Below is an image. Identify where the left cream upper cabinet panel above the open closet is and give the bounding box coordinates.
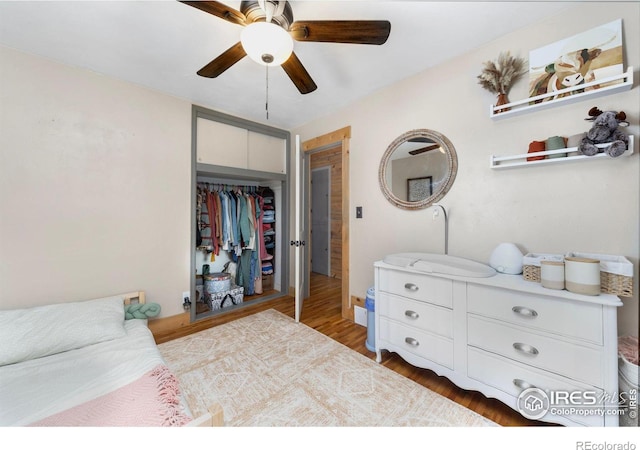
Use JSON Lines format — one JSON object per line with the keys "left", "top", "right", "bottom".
{"left": 196, "top": 119, "right": 248, "bottom": 169}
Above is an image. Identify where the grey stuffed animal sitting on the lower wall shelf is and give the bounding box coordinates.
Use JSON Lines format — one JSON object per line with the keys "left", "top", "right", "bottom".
{"left": 578, "top": 106, "right": 629, "bottom": 158}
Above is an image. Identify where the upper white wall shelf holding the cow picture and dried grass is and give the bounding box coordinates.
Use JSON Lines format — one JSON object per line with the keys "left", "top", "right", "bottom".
{"left": 489, "top": 67, "right": 633, "bottom": 120}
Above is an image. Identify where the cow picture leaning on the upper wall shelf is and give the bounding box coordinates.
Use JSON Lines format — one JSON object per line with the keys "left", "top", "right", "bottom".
{"left": 529, "top": 19, "right": 624, "bottom": 103}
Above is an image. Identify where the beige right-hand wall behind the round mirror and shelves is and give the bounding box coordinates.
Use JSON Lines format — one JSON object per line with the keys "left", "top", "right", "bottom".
{"left": 292, "top": 2, "right": 640, "bottom": 335}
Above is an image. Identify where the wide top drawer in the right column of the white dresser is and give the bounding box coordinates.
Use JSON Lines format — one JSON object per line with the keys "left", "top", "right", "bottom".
{"left": 467, "top": 285, "right": 603, "bottom": 344}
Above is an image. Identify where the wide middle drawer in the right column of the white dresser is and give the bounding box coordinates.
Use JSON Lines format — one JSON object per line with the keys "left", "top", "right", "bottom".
{"left": 467, "top": 315, "right": 604, "bottom": 386}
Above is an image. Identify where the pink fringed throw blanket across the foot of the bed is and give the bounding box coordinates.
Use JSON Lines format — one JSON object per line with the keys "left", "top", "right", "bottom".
{"left": 31, "top": 365, "right": 192, "bottom": 427}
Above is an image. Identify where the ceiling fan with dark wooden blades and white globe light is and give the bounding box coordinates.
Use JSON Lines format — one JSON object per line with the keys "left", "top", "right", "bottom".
{"left": 181, "top": 0, "right": 391, "bottom": 94}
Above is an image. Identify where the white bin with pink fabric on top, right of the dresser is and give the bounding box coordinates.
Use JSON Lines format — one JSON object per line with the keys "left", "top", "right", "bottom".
{"left": 618, "top": 336, "right": 640, "bottom": 427}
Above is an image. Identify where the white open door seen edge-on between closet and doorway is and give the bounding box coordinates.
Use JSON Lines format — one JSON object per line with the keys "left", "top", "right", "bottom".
{"left": 291, "top": 135, "right": 306, "bottom": 322}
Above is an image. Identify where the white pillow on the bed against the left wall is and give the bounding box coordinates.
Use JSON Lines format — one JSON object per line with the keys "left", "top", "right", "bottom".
{"left": 0, "top": 296, "right": 126, "bottom": 366}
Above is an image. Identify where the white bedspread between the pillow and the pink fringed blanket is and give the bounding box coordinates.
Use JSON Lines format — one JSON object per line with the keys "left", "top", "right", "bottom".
{"left": 0, "top": 319, "right": 192, "bottom": 426}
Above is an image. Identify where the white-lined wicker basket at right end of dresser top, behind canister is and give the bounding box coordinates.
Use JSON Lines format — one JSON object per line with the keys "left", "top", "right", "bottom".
{"left": 566, "top": 252, "right": 633, "bottom": 297}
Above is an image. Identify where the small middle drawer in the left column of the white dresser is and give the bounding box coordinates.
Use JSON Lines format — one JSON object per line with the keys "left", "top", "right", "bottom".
{"left": 375, "top": 292, "right": 453, "bottom": 338}
